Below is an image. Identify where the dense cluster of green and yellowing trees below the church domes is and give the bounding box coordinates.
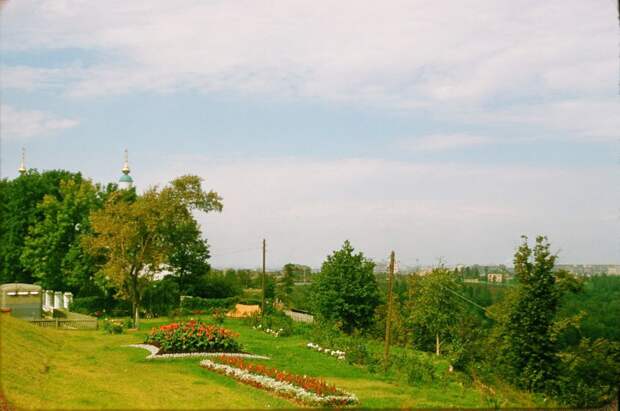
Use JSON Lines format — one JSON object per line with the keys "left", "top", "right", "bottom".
{"left": 0, "top": 170, "right": 222, "bottom": 322}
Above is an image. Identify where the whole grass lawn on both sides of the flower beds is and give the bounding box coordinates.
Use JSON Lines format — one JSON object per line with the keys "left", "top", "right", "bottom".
{"left": 0, "top": 314, "right": 542, "bottom": 409}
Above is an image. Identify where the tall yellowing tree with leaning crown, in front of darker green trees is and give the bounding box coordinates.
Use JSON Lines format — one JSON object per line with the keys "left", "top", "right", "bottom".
{"left": 84, "top": 176, "right": 222, "bottom": 327}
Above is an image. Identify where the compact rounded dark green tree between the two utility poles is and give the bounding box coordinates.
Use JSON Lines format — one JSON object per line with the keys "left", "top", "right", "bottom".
{"left": 312, "top": 241, "right": 380, "bottom": 333}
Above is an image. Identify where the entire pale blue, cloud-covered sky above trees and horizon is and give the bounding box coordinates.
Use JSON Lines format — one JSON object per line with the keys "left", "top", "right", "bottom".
{"left": 0, "top": 0, "right": 620, "bottom": 268}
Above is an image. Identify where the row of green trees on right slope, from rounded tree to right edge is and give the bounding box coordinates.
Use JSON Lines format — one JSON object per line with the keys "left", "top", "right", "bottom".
{"left": 311, "top": 237, "right": 620, "bottom": 406}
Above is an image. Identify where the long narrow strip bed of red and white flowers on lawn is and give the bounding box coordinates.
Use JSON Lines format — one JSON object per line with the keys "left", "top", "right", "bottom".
{"left": 200, "top": 356, "right": 358, "bottom": 406}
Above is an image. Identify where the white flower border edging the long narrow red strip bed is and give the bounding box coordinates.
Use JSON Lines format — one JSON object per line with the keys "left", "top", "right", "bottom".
{"left": 200, "top": 359, "right": 359, "bottom": 406}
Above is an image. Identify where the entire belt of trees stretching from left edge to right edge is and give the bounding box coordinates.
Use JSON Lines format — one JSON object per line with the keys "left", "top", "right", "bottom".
{"left": 0, "top": 170, "right": 620, "bottom": 406}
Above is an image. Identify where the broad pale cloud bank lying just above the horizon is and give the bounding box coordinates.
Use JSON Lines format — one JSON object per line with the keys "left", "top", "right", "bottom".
{"left": 134, "top": 156, "right": 620, "bottom": 267}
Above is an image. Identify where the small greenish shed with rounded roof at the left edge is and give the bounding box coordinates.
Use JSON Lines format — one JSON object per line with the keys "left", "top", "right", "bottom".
{"left": 0, "top": 283, "right": 43, "bottom": 320}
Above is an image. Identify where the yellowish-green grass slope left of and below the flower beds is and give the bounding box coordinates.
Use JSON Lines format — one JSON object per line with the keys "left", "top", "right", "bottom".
{"left": 0, "top": 314, "right": 294, "bottom": 409}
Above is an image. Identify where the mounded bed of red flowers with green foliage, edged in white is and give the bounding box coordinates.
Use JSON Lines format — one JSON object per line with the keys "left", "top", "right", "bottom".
{"left": 144, "top": 320, "right": 241, "bottom": 354}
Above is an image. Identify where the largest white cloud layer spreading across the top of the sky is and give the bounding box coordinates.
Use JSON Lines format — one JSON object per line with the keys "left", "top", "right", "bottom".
{"left": 3, "top": 0, "right": 618, "bottom": 140}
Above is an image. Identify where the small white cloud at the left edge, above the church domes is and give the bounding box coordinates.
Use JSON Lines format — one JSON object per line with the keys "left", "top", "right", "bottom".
{"left": 0, "top": 104, "right": 79, "bottom": 140}
